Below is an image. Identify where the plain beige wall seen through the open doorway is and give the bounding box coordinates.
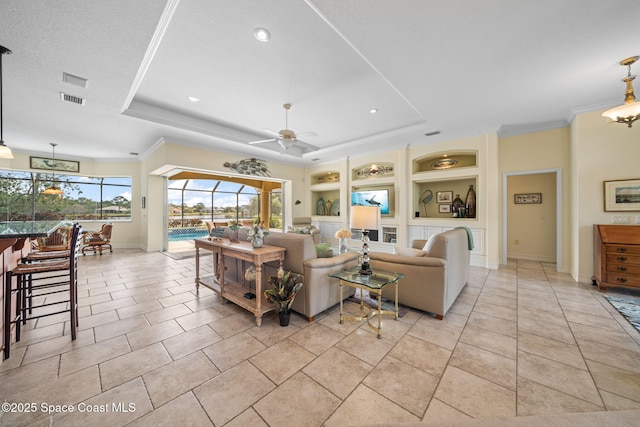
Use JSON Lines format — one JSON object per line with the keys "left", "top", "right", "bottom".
{"left": 506, "top": 173, "right": 556, "bottom": 262}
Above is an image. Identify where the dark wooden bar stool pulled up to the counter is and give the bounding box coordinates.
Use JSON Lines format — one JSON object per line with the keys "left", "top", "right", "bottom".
{"left": 4, "top": 224, "right": 82, "bottom": 359}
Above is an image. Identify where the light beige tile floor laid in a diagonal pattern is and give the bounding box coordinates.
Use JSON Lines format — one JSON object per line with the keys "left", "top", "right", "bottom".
{"left": 0, "top": 250, "right": 640, "bottom": 426}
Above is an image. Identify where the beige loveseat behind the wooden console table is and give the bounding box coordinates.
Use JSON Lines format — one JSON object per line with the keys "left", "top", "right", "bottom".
{"left": 220, "top": 229, "right": 359, "bottom": 322}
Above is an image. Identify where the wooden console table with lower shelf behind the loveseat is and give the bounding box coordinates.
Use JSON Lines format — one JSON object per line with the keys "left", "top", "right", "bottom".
{"left": 195, "top": 239, "right": 286, "bottom": 326}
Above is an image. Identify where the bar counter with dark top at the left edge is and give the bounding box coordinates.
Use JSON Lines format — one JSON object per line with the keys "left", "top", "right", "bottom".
{"left": 0, "top": 220, "right": 62, "bottom": 363}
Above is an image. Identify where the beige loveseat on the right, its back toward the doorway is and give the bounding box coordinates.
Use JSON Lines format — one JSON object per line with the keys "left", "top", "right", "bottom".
{"left": 369, "top": 228, "right": 473, "bottom": 320}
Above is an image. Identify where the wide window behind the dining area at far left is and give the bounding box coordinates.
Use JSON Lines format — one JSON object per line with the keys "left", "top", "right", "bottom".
{"left": 0, "top": 170, "right": 131, "bottom": 221}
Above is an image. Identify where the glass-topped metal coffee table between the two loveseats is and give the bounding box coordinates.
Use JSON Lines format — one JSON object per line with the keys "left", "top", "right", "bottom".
{"left": 329, "top": 266, "right": 404, "bottom": 338}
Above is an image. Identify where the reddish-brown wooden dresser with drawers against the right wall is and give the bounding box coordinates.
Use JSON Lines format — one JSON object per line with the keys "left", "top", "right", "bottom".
{"left": 591, "top": 224, "right": 640, "bottom": 292}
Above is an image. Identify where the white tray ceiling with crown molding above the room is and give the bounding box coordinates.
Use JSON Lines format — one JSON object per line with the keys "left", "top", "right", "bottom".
{"left": 0, "top": 0, "right": 640, "bottom": 164}
